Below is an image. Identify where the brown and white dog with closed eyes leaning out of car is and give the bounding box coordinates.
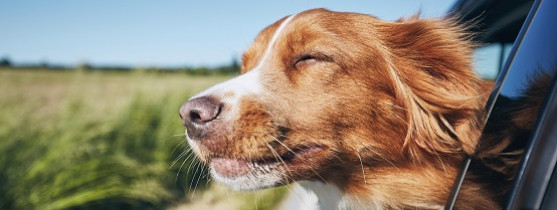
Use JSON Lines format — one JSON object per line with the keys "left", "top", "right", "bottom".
{"left": 180, "top": 9, "right": 528, "bottom": 209}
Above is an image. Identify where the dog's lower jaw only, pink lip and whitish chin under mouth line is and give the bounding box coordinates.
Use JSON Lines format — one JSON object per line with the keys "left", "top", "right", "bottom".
{"left": 210, "top": 145, "right": 326, "bottom": 184}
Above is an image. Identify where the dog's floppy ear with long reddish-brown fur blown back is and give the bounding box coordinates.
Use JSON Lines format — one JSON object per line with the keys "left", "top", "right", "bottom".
{"left": 381, "top": 18, "right": 488, "bottom": 158}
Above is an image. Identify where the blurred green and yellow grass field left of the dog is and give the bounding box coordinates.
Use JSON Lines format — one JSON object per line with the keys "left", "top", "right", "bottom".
{"left": 0, "top": 69, "right": 284, "bottom": 209}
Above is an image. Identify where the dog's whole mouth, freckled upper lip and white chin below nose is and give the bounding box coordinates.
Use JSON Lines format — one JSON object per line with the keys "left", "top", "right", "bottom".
{"left": 182, "top": 108, "right": 334, "bottom": 190}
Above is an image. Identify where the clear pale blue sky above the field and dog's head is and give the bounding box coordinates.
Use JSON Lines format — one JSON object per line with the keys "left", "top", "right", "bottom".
{"left": 0, "top": 0, "right": 454, "bottom": 67}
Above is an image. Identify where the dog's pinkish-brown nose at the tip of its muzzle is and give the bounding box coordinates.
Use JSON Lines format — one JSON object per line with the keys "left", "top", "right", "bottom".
{"left": 180, "top": 97, "right": 221, "bottom": 127}
